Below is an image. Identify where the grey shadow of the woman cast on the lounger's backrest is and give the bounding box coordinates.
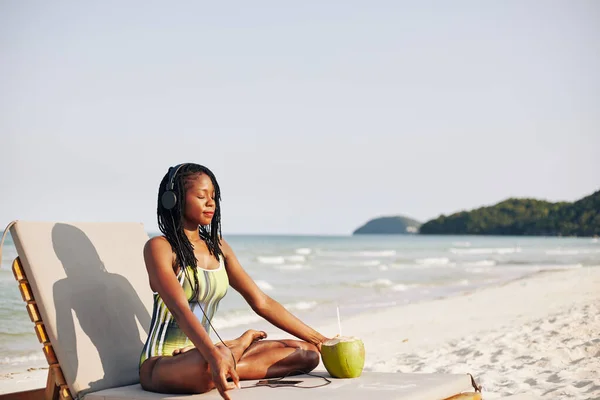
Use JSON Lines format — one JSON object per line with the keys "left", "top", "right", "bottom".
{"left": 52, "top": 224, "right": 150, "bottom": 390}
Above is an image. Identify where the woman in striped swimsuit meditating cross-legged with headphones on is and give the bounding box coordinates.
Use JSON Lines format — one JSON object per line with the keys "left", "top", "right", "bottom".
{"left": 140, "top": 164, "right": 327, "bottom": 399}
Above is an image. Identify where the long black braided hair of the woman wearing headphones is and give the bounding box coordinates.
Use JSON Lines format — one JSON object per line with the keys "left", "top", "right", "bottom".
{"left": 157, "top": 163, "right": 223, "bottom": 298}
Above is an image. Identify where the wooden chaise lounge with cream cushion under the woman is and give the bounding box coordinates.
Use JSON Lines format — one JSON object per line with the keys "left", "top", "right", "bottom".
{"left": 0, "top": 221, "right": 488, "bottom": 400}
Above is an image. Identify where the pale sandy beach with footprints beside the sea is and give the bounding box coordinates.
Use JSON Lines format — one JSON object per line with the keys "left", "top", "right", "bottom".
{"left": 0, "top": 268, "right": 600, "bottom": 399}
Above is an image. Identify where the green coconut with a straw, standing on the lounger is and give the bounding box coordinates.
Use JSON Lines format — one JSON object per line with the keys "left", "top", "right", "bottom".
{"left": 321, "top": 336, "right": 365, "bottom": 378}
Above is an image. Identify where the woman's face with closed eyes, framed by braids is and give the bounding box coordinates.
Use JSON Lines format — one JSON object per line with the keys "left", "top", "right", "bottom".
{"left": 183, "top": 173, "right": 216, "bottom": 225}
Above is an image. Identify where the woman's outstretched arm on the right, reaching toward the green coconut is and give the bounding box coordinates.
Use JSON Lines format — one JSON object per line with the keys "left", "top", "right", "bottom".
{"left": 221, "top": 240, "right": 327, "bottom": 350}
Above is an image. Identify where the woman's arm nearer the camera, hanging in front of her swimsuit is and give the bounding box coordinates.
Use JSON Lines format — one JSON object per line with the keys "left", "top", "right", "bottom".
{"left": 144, "top": 237, "right": 239, "bottom": 399}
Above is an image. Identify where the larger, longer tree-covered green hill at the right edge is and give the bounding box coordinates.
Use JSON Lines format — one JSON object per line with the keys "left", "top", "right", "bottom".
{"left": 420, "top": 191, "right": 600, "bottom": 236}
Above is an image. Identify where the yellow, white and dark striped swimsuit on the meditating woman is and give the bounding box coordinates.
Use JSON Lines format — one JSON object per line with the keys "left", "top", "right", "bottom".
{"left": 140, "top": 257, "right": 229, "bottom": 366}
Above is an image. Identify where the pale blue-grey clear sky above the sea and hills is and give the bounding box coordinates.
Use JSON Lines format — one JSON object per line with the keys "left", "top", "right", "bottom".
{"left": 0, "top": 0, "right": 600, "bottom": 235}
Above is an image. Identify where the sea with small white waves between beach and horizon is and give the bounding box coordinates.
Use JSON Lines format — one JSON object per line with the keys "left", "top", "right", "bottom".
{"left": 0, "top": 232, "right": 600, "bottom": 371}
